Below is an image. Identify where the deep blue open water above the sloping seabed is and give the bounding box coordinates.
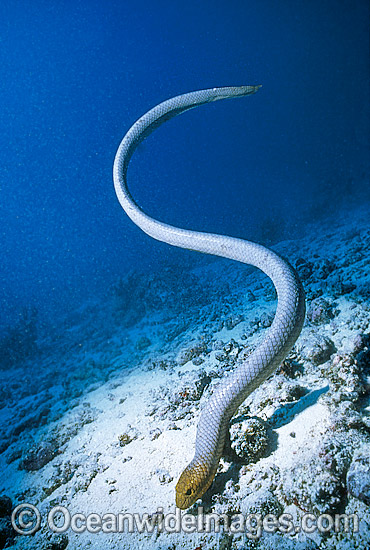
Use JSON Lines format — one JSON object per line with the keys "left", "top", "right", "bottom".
{"left": 0, "top": 0, "right": 370, "bottom": 548}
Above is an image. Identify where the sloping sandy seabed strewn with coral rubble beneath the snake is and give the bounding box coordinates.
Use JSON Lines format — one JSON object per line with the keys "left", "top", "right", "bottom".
{"left": 0, "top": 207, "right": 370, "bottom": 550}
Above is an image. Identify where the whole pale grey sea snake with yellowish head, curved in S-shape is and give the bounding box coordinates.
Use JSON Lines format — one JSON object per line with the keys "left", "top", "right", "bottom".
{"left": 113, "top": 86, "right": 305, "bottom": 510}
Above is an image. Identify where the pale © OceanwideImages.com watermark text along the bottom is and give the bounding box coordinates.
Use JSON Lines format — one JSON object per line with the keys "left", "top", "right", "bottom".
{"left": 11, "top": 503, "right": 359, "bottom": 539}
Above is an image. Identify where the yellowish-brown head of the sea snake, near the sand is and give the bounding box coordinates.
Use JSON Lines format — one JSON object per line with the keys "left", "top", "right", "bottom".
{"left": 176, "top": 460, "right": 217, "bottom": 510}
